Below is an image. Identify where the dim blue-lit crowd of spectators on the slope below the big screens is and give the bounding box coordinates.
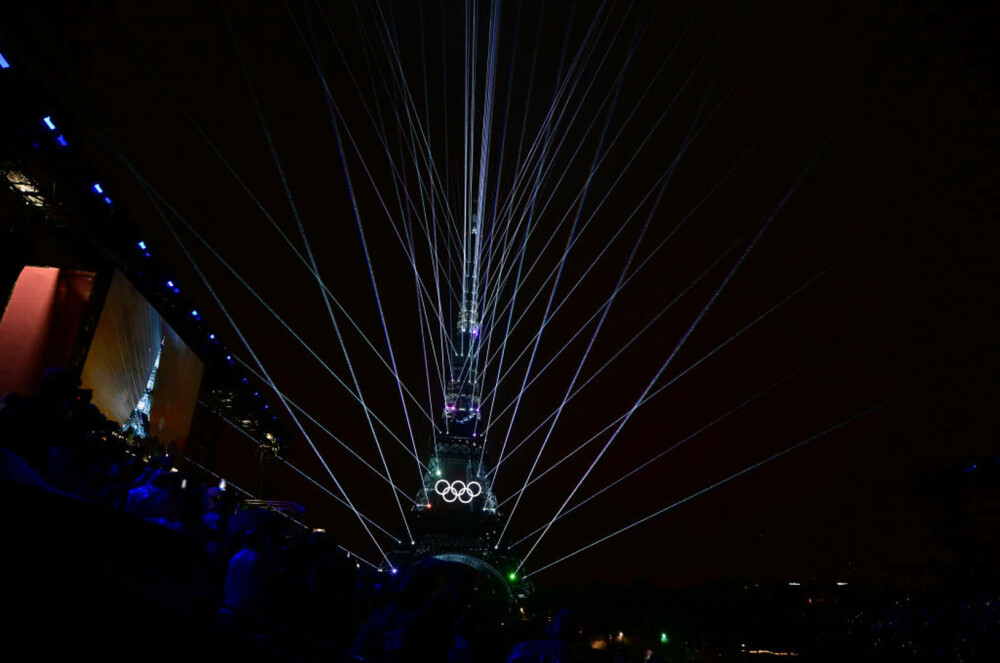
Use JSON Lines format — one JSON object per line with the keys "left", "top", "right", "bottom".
{"left": 0, "top": 369, "right": 613, "bottom": 663}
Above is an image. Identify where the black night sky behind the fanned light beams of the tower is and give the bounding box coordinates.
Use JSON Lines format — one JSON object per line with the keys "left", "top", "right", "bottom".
{"left": 2, "top": 0, "right": 997, "bottom": 585}
